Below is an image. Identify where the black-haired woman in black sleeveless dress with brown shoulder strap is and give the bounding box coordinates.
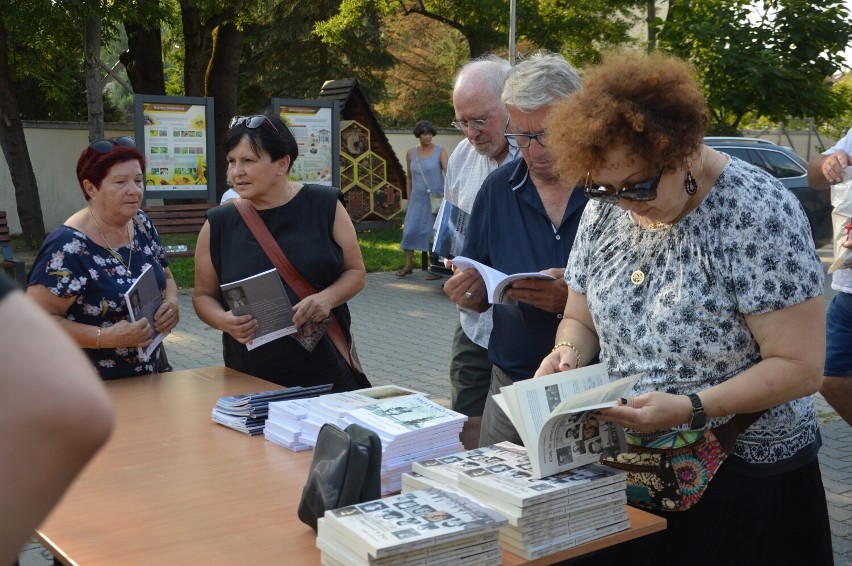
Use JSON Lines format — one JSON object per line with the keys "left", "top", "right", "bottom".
{"left": 192, "top": 116, "right": 366, "bottom": 391}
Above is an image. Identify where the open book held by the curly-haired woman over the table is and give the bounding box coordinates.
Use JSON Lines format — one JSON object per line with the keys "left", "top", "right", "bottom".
{"left": 494, "top": 364, "right": 639, "bottom": 479}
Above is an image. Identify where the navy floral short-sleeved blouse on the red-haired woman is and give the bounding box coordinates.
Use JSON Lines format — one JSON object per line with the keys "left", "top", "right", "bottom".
{"left": 28, "top": 210, "right": 169, "bottom": 379}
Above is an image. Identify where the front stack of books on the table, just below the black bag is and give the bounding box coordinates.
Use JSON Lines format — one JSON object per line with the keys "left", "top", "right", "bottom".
{"left": 317, "top": 489, "right": 506, "bottom": 566}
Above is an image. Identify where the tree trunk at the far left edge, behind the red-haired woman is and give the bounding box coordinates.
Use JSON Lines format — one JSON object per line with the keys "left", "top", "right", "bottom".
{"left": 0, "top": 18, "right": 45, "bottom": 249}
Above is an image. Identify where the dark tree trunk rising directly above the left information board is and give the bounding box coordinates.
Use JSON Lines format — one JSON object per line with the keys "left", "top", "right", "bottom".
{"left": 121, "top": 18, "right": 166, "bottom": 96}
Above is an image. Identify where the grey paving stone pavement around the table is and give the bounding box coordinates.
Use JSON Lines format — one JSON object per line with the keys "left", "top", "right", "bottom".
{"left": 20, "top": 264, "right": 852, "bottom": 566}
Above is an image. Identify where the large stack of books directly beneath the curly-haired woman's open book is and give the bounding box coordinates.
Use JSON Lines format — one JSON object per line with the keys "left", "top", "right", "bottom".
{"left": 403, "top": 442, "right": 630, "bottom": 560}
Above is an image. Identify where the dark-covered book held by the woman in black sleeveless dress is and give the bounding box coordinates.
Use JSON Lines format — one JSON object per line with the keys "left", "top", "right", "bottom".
{"left": 220, "top": 269, "right": 296, "bottom": 350}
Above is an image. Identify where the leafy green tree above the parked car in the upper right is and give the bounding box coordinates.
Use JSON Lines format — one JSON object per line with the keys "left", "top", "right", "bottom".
{"left": 658, "top": 0, "right": 852, "bottom": 134}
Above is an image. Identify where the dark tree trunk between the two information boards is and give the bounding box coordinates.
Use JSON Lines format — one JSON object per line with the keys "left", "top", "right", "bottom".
{"left": 205, "top": 23, "right": 243, "bottom": 202}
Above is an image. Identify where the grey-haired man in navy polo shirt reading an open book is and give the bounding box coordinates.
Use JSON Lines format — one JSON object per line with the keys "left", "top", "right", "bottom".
{"left": 444, "top": 53, "right": 587, "bottom": 446}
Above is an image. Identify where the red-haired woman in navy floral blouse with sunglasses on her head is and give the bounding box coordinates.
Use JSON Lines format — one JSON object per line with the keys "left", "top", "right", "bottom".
{"left": 27, "top": 136, "right": 179, "bottom": 379}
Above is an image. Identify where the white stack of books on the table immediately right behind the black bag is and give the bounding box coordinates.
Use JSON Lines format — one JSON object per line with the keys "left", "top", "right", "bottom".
{"left": 341, "top": 395, "right": 467, "bottom": 495}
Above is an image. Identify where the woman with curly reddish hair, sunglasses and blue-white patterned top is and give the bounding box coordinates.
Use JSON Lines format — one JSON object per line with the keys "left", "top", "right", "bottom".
{"left": 537, "top": 53, "right": 833, "bottom": 565}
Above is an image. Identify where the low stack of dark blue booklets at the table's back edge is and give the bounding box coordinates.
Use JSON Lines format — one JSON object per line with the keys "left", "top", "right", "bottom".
{"left": 211, "top": 384, "right": 331, "bottom": 436}
